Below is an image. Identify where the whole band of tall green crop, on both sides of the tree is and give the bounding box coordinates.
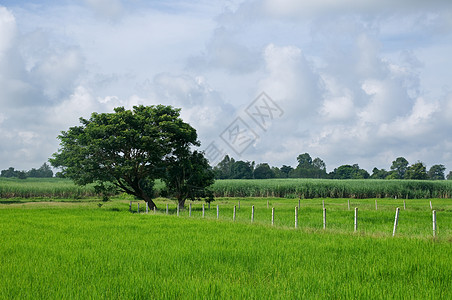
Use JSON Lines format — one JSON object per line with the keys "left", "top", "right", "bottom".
{"left": 0, "top": 178, "right": 452, "bottom": 199}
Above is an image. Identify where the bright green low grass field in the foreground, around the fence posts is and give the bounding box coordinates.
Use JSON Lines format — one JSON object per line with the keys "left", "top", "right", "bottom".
{"left": 0, "top": 198, "right": 452, "bottom": 299}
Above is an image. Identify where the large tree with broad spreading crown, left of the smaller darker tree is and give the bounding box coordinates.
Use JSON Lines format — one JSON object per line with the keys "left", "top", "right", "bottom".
{"left": 49, "top": 105, "right": 204, "bottom": 209}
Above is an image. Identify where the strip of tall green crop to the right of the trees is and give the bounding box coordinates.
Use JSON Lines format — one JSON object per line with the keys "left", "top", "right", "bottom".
{"left": 212, "top": 179, "right": 452, "bottom": 199}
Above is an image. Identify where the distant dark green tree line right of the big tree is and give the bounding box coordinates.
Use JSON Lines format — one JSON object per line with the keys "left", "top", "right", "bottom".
{"left": 213, "top": 153, "right": 452, "bottom": 180}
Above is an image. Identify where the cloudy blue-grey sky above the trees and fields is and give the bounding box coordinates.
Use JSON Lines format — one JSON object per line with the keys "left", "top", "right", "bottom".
{"left": 0, "top": 0, "right": 452, "bottom": 172}
